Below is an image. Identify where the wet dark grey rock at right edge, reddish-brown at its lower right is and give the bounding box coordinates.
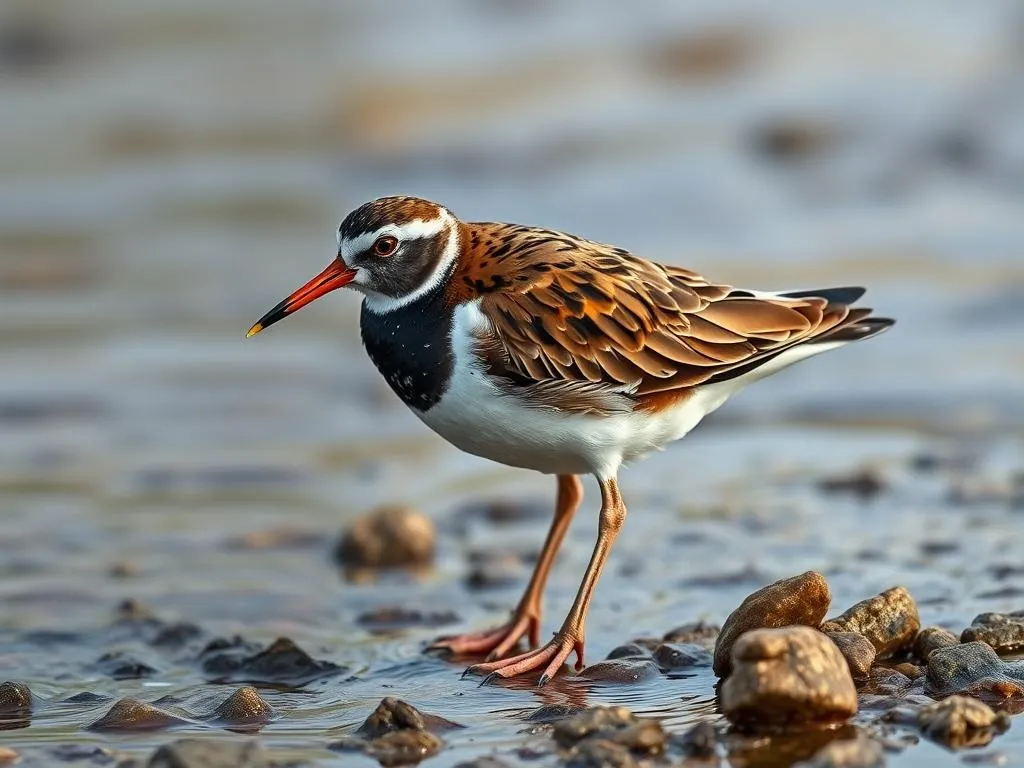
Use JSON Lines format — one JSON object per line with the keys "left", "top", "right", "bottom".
{"left": 925, "top": 642, "right": 1024, "bottom": 699}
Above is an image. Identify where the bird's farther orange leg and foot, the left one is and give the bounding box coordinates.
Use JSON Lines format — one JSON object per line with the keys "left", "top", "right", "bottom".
{"left": 429, "top": 475, "right": 583, "bottom": 660}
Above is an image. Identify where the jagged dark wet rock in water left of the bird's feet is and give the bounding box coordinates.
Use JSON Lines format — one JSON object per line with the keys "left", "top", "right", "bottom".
{"left": 203, "top": 637, "right": 345, "bottom": 686}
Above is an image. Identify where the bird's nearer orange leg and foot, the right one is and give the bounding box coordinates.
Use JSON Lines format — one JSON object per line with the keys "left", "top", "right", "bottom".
{"left": 467, "top": 478, "right": 626, "bottom": 685}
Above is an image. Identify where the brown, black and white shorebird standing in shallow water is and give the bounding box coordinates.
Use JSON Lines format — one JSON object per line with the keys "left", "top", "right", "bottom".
{"left": 248, "top": 196, "right": 894, "bottom": 685}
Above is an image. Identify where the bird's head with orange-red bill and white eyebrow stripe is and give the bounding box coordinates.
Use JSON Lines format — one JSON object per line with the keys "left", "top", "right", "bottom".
{"left": 248, "top": 197, "right": 459, "bottom": 336}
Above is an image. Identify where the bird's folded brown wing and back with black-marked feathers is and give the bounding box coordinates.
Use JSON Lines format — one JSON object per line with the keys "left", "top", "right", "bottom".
{"left": 453, "top": 224, "right": 869, "bottom": 411}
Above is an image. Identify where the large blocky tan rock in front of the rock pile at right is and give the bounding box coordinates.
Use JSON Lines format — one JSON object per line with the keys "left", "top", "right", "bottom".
{"left": 720, "top": 627, "right": 857, "bottom": 727}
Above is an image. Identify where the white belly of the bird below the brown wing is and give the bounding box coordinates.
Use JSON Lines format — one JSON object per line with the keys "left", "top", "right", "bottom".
{"left": 414, "top": 305, "right": 728, "bottom": 477}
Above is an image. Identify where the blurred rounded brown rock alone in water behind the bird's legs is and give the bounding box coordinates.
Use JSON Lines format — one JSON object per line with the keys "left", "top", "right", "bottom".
{"left": 335, "top": 505, "right": 434, "bottom": 568}
